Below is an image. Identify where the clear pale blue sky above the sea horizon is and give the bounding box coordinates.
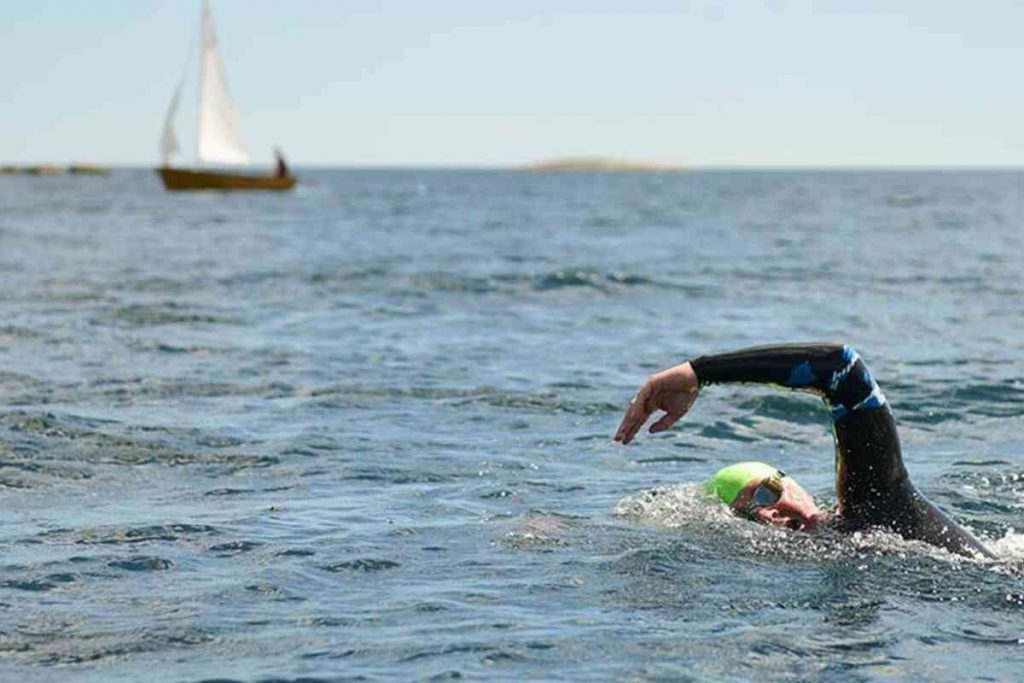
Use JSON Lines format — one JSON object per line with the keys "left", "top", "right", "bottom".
{"left": 0, "top": 0, "right": 1024, "bottom": 168}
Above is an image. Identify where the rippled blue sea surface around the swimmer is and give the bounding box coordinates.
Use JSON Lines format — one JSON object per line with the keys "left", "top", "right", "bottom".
{"left": 0, "top": 169, "right": 1024, "bottom": 682}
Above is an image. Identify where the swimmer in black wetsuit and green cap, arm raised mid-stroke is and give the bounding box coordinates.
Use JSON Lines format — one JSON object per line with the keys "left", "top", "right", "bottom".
{"left": 614, "top": 343, "right": 993, "bottom": 557}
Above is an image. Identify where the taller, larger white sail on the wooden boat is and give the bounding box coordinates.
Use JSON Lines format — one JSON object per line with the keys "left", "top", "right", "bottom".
{"left": 198, "top": 0, "right": 251, "bottom": 164}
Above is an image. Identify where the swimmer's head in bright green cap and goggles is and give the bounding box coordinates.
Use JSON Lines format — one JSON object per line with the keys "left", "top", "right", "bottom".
{"left": 705, "top": 462, "right": 822, "bottom": 531}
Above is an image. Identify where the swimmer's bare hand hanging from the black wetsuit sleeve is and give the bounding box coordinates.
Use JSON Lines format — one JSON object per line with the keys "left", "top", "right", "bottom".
{"left": 614, "top": 362, "right": 700, "bottom": 444}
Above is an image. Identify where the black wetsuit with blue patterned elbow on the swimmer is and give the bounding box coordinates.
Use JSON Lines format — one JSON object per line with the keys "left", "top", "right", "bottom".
{"left": 690, "top": 343, "right": 992, "bottom": 557}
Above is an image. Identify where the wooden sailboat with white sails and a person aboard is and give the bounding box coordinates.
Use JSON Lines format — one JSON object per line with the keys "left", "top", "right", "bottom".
{"left": 157, "top": 0, "right": 296, "bottom": 190}
